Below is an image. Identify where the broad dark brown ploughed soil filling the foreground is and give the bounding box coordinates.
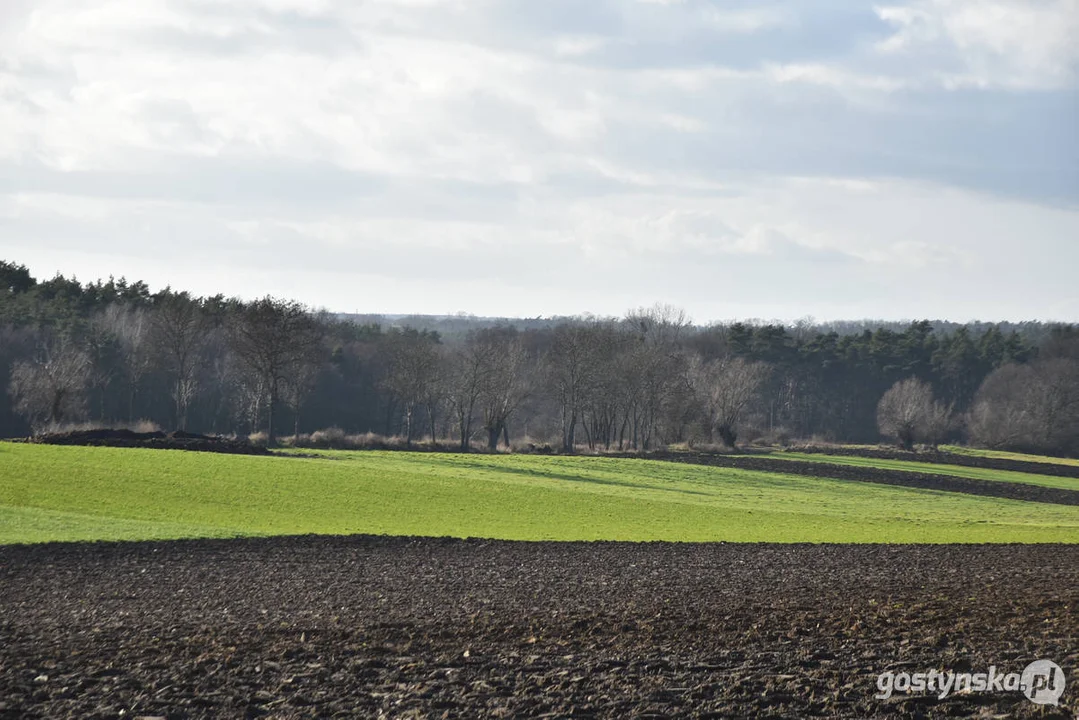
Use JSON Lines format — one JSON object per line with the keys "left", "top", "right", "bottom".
{"left": 0, "top": 536, "right": 1079, "bottom": 720}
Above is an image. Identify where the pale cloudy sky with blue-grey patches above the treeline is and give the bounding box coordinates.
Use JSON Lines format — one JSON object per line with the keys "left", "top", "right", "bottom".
{"left": 0, "top": 0, "right": 1079, "bottom": 322}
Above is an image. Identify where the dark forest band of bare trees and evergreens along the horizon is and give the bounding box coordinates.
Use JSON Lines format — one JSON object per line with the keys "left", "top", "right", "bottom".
{"left": 6, "top": 261, "right": 1079, "bottom": 454}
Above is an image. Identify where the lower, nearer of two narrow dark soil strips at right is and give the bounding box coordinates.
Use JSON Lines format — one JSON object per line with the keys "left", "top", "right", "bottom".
{"left": 622, "top": 450, "right": 1079, "bottom": 505}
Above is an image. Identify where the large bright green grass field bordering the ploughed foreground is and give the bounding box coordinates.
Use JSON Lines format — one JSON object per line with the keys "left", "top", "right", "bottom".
{"left": 0, "top": 443, "right": 1079, "bottom": 544}
